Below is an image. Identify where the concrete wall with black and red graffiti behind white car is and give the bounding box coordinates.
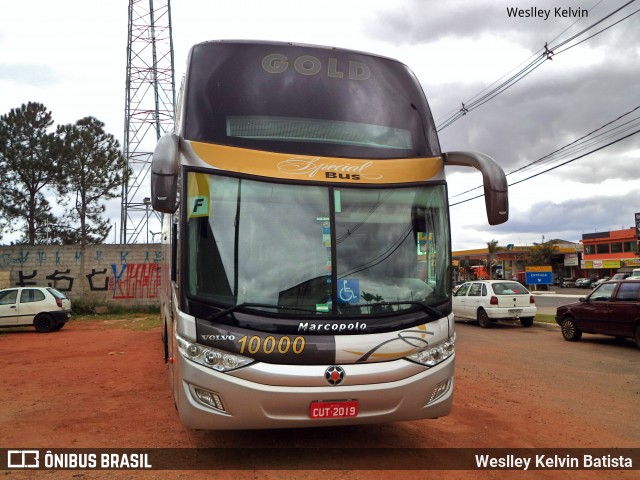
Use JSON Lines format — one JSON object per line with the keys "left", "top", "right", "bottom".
{"left": 0, "top": 244, "right": 162, "bottom": 307}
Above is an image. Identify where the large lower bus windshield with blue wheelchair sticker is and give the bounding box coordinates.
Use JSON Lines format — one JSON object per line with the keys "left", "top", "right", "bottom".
{"left": 186, "top": 172, "right": 450, "bottom": 316}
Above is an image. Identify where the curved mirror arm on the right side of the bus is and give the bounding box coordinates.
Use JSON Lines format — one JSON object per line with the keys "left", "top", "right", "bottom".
{"left": 442, "top": 152, "right": 509, "bottom": 225}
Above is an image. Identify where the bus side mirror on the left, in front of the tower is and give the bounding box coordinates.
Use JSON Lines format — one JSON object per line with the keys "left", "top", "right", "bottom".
{"left": 151, "top": 133, "right": 180, "bottom": 213}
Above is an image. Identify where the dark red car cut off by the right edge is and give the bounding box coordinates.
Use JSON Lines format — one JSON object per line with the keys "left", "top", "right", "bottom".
{"left": 556, "top": 279, "right": 640, "bottom": 348}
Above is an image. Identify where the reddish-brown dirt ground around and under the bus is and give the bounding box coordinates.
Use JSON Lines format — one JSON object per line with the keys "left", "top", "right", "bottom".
{"left": 0, "top": 320, "right": 640, "bottom": 480}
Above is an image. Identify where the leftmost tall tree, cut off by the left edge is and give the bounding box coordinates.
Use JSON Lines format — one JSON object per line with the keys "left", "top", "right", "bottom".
{"left": 0, "top": 102, "right": 61, "bottom": 245}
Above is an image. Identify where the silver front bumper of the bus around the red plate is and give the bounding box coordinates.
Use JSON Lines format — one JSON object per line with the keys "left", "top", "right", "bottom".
{"left": 173, "top": 355, "right": 455, "bottom": 430}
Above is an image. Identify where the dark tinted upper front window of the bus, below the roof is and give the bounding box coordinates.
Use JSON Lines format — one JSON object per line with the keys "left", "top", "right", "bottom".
{"left": 182, "top": 42, "right": 440, "bottom": 158}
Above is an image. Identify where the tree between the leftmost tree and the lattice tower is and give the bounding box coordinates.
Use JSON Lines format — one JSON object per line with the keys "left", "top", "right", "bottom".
{"left": 58, "top": 117, "right": 127, "bottom": 245}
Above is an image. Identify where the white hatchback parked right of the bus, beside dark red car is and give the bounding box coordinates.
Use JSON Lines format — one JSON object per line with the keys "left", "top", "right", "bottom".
{"left": 453, "top": 280, "right": 537, "bottom": 328}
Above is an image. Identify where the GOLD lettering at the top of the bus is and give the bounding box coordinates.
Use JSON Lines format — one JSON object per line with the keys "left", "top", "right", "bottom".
{"left": 262, "top": 53, "right": 371, "bottom": 80}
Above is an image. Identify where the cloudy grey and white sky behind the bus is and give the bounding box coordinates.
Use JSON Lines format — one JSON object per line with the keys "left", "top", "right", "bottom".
{"left": 0, "top": 0, "right": 640, "bottom": 250}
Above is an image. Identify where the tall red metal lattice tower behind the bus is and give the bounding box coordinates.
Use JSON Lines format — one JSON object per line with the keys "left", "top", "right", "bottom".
{"left": 120, "top": 0, "right": 175, "bottom": 243}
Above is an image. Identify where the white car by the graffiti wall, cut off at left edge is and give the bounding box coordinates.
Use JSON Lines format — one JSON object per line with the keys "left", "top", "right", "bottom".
{"left": 0, "top": 287, "right": 71, "bottom": 332}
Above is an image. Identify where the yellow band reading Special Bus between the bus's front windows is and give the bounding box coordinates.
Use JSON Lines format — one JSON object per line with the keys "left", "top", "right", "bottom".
{"left": 189, "top": 142, "right": 443, "bottom": 184}
